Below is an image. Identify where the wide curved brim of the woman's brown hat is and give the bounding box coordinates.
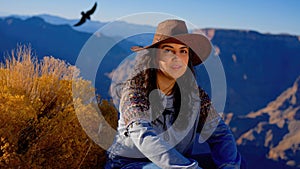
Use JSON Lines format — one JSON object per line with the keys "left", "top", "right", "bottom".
{"left": 131, "top": 34, "right": 212, "bottom": 66}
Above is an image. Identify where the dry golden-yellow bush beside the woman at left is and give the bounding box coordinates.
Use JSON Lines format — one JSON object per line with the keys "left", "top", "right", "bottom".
{"left": 0, "top": 46, "right": 117, "bottom": 168}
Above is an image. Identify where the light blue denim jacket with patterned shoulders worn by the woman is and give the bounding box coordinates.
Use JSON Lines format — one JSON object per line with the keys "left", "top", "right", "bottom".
{"left": 108, "top": 88, "right": 241, "bottom": 169}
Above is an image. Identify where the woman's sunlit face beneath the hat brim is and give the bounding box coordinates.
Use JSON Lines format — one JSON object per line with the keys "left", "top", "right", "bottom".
{"left": 156, "top": 43, "right": 189, "bottom": 79}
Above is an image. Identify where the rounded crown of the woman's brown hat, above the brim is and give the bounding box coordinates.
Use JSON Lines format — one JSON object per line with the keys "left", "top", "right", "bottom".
{"left": 153, "top": 19, "right": 188, "bottom": 43}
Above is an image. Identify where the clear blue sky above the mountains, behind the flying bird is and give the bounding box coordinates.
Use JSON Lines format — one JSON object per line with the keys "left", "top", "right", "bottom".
{"left": 0, "top": 0, "right": 300, "bottom": 35}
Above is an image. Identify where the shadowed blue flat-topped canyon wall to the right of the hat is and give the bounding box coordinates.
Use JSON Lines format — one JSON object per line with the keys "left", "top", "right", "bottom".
{"left": 195, "top": 29, "right": 300, "bottom": 114}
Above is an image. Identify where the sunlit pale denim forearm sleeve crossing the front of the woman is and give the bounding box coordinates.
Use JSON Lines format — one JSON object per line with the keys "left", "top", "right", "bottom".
{"left": 128, "top": 120, "right": 201, "bottom": 169}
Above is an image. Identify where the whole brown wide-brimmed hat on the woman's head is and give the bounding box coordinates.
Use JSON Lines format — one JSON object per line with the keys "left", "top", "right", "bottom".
{"left": 131, "top": 19, "right": 212, "bottom": 66}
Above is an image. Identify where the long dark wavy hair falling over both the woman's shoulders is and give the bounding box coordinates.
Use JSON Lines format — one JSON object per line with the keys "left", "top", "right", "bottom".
{"left": 125, "top": 48, "right": 202, "bottom": 130}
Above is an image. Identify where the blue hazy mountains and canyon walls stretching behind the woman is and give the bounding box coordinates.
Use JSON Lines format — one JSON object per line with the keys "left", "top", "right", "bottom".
{"left": 0, "top": 15, "right": 300, "bottom": 168}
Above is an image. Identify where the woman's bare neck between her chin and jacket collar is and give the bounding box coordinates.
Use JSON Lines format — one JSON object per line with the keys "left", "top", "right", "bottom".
{"left": 156, "top": 71, "right": 176, "bottom": 95}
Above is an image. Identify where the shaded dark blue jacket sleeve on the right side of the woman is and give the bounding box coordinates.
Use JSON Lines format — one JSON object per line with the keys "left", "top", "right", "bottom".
{"left": 198, "top": 90, "right": 241, "bottom": 169}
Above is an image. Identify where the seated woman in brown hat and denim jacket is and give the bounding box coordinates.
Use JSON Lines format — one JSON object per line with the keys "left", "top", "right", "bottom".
{"left": 105, "top": 20, "right": 241, "bottom": 169}
